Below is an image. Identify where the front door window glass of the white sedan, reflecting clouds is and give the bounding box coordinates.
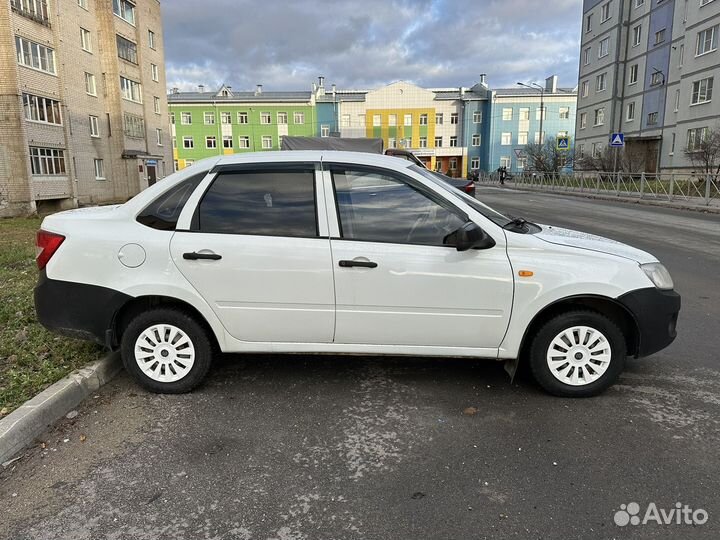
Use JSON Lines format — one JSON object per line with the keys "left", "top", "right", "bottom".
{"left": 331, "top": 166, "right": 466, "bottom": 246}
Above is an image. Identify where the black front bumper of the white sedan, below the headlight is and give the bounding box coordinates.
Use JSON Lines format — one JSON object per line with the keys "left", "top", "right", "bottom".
{"left": 618, "top": 287, "right": 680, "bottom": 358}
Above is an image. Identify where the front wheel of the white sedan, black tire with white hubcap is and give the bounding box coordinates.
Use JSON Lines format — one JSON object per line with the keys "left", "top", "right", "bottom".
{"left": 529, "top": 311, "right": 627, "bottom": 397}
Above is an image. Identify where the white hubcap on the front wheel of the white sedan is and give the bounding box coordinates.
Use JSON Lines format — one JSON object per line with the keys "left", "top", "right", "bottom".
{"left": 547, "top": 326, "right": 612, "bottom": 386}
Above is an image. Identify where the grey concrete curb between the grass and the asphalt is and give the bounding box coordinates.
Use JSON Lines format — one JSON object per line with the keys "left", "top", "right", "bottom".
{"left": 0, "top": 353, "right": 122, "bottom": 463}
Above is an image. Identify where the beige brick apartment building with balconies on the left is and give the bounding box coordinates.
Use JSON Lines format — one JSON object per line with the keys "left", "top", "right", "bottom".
{"left": 0, "top": 0, "right": 172, "bottom": 216}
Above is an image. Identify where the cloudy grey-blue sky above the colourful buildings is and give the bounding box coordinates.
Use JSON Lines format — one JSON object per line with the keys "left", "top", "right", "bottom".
{"left": 162, "top": 0, "right": 582, "bottom": 90}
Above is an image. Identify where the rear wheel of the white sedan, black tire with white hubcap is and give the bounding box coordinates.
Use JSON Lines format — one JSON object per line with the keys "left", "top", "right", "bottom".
{"left": 120, "top": 308, "right": 213, "bottom": 394}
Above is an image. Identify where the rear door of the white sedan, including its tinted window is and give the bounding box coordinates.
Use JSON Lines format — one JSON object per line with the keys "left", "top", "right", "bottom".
{"left": 170, "top": 163, "right": 335, "bottom": 343}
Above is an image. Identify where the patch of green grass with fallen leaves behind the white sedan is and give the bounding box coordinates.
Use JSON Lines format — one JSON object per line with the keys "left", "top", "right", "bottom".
{"left": 0, "top": 218, "right": 103, "bottom": 417}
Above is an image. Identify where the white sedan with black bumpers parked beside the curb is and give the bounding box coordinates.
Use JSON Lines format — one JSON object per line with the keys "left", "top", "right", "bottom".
{"left": 35, "top": 151, "right": 680, "bottom": 396}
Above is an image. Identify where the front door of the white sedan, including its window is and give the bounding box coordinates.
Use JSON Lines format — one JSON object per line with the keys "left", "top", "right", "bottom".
{"left": 324, "top": 164, "right": 513, "bottom": 354}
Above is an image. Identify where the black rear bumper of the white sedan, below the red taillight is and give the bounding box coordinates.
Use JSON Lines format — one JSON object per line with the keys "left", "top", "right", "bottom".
{"left": 35, "top": 270, "right": 131, "bottom": 347}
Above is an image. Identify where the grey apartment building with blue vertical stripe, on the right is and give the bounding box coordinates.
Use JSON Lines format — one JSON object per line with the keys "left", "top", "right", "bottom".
{"left": 576, "top": 0, "right": 720, "bottom": 172}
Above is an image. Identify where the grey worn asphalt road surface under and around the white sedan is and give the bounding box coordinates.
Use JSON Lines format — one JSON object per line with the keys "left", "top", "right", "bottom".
{"left": 0, "top": 188, "right": 720, "bottom": 540}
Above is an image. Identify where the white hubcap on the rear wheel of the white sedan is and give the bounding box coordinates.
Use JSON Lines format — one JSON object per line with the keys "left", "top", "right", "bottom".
{"left": 135, "top": 324, "right": 195, "bottom": 382}
